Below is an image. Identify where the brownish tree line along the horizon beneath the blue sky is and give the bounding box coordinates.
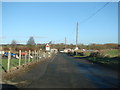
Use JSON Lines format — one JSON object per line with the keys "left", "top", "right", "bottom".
{"left": 2, "top": 37, "right": 120, "bottom": 51}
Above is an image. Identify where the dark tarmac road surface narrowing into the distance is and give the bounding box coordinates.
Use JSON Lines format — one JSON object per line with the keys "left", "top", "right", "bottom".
{"left": 3, "top": 53, "right": 119, "bottom": 88}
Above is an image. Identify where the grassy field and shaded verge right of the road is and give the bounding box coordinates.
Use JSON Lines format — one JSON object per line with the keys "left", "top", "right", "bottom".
{"left": 70, "top": 49, "right": 120, "bottom": 69}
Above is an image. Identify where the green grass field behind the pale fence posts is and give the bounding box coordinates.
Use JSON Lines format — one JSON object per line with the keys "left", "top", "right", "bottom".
{"left": 0, "top": 52, "right": 52, "bottom": 72}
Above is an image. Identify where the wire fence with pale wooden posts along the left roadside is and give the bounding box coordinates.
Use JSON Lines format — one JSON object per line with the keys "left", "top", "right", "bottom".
{"left": 0, "top": 50, "right": 53, "bottom": 72}
